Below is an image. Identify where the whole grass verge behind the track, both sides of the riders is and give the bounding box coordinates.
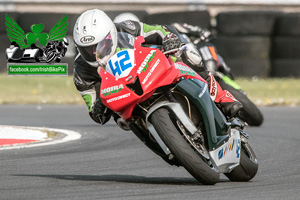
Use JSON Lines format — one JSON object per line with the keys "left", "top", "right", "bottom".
{"left": 0, "top": 75, "right": 300, "bottom": 106}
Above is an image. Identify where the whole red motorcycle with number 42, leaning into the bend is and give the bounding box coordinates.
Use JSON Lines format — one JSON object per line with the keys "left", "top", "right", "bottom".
{"left": 98, "top": 33, "right": 258, "bottom": 184}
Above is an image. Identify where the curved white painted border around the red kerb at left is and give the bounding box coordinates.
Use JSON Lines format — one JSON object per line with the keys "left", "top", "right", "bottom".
{"left": 0, "top": 126, "right": 81, "bottom": 150}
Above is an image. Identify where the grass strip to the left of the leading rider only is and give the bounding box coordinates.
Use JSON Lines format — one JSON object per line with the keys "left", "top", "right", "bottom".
{"left": 0, "top": 75, "right": 84, "bottom": 104}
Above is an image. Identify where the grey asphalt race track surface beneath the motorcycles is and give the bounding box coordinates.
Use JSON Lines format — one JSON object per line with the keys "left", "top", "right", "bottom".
{"left": 0, "top": 105, "right": 300, "bottom": 200}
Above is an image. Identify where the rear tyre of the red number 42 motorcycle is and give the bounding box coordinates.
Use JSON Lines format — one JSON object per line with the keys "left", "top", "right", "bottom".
{"left": 225, "top": 142, "right": 258, "bottom": 182}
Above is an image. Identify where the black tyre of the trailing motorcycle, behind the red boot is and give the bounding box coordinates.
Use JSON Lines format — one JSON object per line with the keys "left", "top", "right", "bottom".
{"left": 218, "top": 79, "right": 264, "bottom": 126}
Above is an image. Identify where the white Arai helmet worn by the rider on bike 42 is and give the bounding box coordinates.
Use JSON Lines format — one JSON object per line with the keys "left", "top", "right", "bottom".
{"left": 73, "top": 9, "right": 117, "bottom": 67}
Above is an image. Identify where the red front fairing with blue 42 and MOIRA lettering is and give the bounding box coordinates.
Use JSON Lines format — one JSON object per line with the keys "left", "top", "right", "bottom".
{"left": 98, "top": 37, "right": 204, "bottom": 119}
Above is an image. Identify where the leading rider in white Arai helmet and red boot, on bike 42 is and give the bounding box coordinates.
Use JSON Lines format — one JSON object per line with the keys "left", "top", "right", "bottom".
{"left": 73, "top": 9, "right": 242, "bottom": 124}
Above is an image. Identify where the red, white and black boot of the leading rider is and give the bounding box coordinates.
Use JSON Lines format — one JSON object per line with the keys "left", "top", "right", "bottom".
{"left": 208, "top": 74, "right": 243, "bottom": 118}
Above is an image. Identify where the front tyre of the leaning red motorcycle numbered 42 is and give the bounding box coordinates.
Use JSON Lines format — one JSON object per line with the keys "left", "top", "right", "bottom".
{"left": 151, "top": 108, "right": 220, "bottom": 185}
